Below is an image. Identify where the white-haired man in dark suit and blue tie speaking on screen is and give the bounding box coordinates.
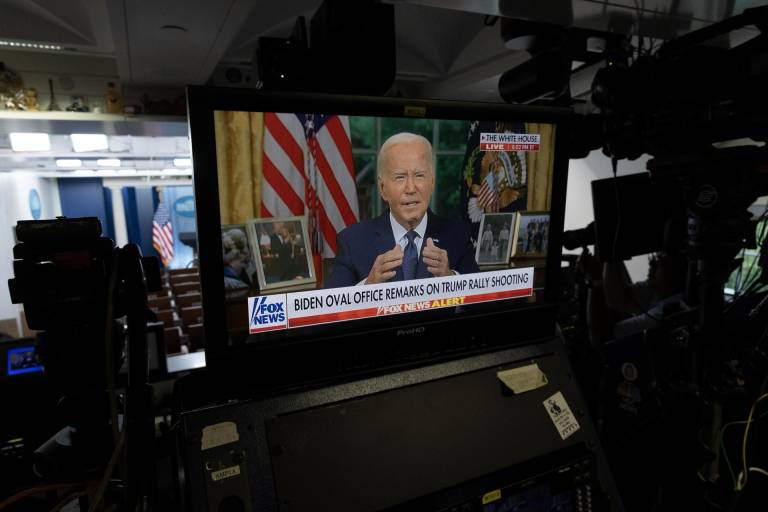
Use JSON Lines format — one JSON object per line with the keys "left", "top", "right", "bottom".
{"left": 325, "top": 133, "right": 479, "bottom": 288}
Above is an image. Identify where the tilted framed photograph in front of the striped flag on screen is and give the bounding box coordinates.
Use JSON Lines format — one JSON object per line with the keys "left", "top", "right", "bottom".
{"left": 248, "top": 217, "right": 317, "bottom": 291}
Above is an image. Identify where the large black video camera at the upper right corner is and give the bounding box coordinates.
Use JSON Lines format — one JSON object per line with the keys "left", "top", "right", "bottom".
{"left": 592, "top": 7, "right": 768, "bottom": 159}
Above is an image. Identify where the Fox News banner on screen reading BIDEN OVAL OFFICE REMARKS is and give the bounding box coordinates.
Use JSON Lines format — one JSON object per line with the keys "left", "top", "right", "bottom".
{"left": 248, "top": 268, "right": 533, "bottom": 334}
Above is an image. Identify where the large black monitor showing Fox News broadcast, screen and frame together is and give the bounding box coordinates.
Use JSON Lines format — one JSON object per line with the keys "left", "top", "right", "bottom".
{"left": 187, "top": 87, "right": 570, "bottom": 383}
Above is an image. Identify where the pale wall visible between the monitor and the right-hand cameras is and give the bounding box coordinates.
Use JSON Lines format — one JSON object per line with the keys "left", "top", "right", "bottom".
{"left": 565, "top": 150, "right": 649, "bottom": 281}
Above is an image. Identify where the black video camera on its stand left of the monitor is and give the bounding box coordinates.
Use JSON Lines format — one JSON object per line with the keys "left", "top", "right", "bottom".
{"left": 8, "top": 217, "right": 160, "bottom": 506}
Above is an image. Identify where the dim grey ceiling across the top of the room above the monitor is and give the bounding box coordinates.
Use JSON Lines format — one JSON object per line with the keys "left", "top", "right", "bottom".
{"left": 0, "top": 0, "right": 764, "bottom": 97}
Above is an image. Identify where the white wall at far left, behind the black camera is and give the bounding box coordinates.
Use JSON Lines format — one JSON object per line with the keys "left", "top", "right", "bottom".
{"left": 0, "top": 173, "right": 61, "bottom": 320}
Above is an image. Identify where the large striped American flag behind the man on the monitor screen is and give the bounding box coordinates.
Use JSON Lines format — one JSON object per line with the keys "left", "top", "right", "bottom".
{"left": 261, "top": 113, "right": 360, "bottom": 257}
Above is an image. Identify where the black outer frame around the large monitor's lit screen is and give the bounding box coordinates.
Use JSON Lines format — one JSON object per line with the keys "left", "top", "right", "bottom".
{"left": 187, "top": 86, "right": 572, "bottom": 387}
